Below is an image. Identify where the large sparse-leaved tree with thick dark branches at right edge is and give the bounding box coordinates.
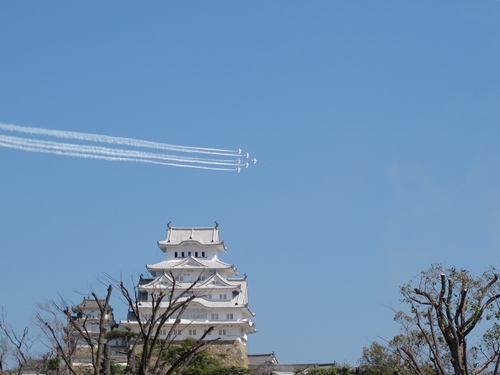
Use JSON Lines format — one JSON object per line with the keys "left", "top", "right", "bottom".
{"left": 391, "top": 265, "right": 500, "bottom": 375}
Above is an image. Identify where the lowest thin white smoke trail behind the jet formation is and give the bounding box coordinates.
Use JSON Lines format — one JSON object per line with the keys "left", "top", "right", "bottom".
{"left": 0, "top": 138, "right": 237, "bottom": 172}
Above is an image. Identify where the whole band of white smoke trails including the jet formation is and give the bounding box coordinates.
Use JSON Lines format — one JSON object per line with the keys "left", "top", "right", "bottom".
{"left": 0, "top": 123, "right": 252, "bottom": 172}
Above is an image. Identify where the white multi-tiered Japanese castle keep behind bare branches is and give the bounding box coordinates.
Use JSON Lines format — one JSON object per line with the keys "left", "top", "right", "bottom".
{"left": 120, "top": 222, "right": 256, "bottom": 344}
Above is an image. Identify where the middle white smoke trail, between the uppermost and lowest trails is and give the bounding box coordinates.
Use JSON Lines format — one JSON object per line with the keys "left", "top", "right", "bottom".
{"left": 0, "top": 134, "right": 241, "bottom": 166}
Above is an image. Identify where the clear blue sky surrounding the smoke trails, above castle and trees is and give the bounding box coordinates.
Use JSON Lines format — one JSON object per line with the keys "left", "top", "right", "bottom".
{"left": 0, "top": 0, "right": 500, "bottom": 365}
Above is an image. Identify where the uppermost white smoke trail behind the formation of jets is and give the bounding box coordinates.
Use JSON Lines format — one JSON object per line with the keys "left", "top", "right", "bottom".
{"left": 0, "top": 123, "right": 241, "bottom": 156}
